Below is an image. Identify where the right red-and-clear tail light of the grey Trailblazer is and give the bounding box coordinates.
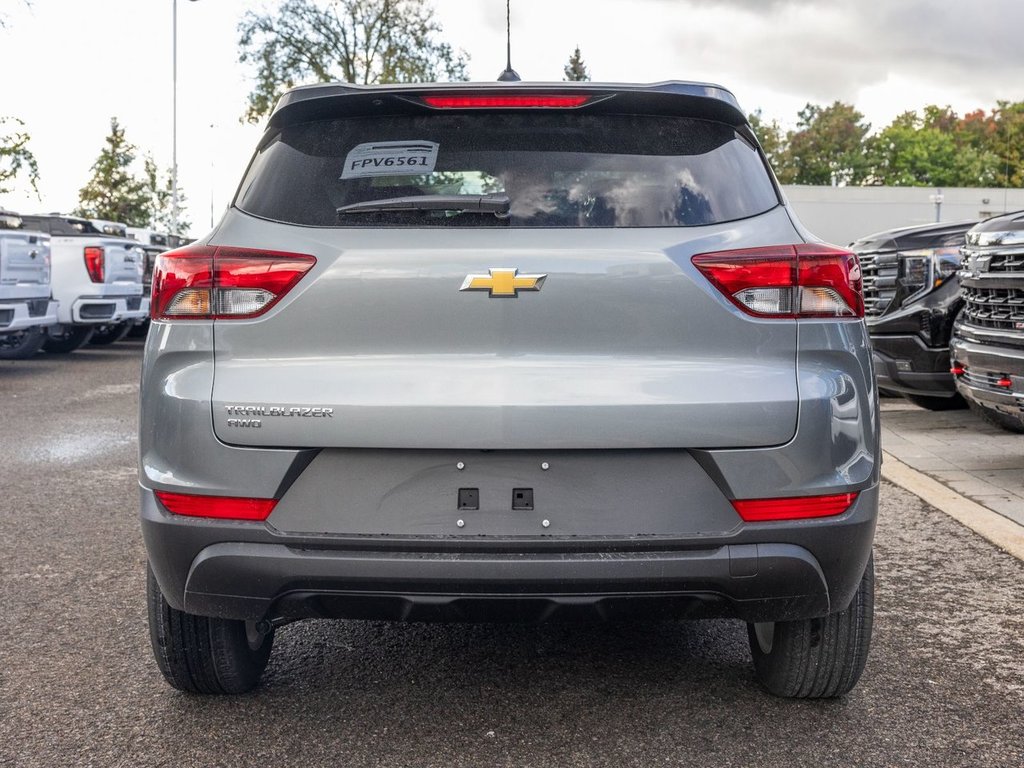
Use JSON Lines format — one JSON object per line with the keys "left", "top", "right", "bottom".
{"left": 692, "top": 243, "right": 864, "bottom": 317}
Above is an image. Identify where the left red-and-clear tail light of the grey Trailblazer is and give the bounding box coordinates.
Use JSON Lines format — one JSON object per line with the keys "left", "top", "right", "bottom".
{"left": 151, "top": 246, "right": 316, "bottom": 319}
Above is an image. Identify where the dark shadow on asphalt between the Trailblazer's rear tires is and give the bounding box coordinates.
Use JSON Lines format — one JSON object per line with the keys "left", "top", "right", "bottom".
{"left": 263, "top": 621, "right": 754, "bottom": 697}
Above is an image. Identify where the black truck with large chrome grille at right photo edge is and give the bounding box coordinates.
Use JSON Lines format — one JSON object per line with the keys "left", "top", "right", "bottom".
{"left": 951, "top": 211, "right": 1024, "bottom": 432}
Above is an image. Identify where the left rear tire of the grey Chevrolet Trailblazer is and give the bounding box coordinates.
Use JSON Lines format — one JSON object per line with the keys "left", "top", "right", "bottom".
{"left": 146, "top": 568, "right": 273, "bottom": 694}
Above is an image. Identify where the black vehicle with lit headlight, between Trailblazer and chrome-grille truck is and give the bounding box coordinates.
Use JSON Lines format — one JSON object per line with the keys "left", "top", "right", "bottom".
{"left": 852, "top": 221, "right": 974, "bottom": 411}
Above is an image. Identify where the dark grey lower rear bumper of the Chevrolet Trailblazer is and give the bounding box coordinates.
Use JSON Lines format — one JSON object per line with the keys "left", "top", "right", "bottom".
{"left": 141, "top": 485, "right": 878, "bottom": 621}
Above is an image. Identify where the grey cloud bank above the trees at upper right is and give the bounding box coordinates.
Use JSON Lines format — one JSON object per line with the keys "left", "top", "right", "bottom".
{"left": 657, "top": 0, "right": 1024, "bottom": 106}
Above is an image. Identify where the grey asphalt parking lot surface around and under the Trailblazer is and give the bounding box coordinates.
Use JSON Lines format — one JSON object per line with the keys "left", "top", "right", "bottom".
{"left": 0, "top": 343, "right": 1024, "bottom": 768}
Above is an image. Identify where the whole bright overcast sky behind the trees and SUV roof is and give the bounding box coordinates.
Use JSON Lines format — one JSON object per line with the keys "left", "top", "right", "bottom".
{"left": 0, "top": 0, "right": 1024, "bottom": 236}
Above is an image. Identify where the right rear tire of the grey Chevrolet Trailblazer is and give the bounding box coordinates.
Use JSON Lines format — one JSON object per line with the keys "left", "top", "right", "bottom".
{"left": 746, "top": 557, "right": 874, "bottom": 698}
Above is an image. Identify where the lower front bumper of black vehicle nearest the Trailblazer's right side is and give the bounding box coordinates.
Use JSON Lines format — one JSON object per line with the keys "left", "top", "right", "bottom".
{"left": 871, "top": 336, "right": 956, "bottom": 397}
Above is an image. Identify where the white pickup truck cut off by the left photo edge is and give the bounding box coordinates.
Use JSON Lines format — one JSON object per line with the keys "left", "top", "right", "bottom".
{"left": 0, "top": 211, "right": 57, "bottom": 360}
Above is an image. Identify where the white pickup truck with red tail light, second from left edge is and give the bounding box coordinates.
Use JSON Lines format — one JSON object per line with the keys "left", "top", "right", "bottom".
{"left": 23, "top": 214, "right": 150, "bottom": 352}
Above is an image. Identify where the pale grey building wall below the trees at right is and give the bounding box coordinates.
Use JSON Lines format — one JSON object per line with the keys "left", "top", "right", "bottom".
{"left": 782, "top": 184, "right": 1024, "bottom": 246}
